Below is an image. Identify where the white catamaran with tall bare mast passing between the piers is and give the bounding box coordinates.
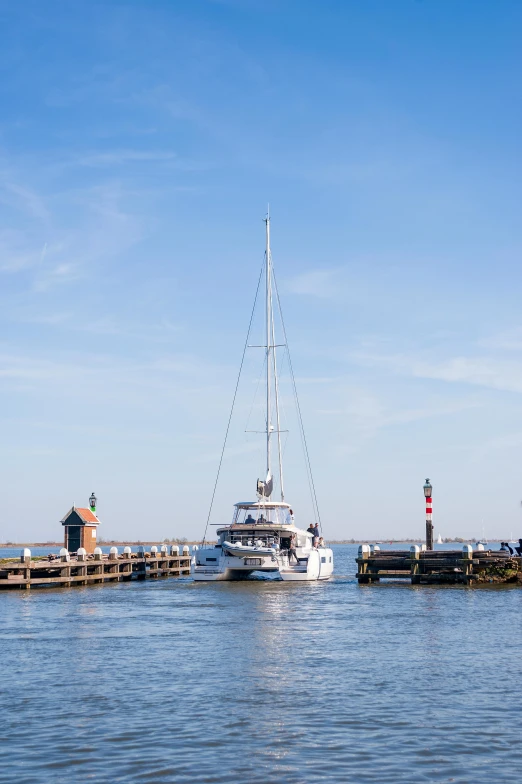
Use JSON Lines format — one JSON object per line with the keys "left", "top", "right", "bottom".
{"left": 192, "top": 215, "right": 333, "bottom": 581}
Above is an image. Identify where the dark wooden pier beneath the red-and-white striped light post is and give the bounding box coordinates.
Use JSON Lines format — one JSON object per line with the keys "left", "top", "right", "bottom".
{"left": 356, "top": 544, "right": 522, "bottom": 585}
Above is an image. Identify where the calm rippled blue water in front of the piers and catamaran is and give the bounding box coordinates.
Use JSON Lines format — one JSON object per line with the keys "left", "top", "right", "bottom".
{"left": 0, "top": 545, "right": 522, "bottom": 784}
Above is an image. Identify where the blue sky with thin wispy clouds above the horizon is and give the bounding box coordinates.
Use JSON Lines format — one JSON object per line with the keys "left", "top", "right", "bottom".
{"left": 0, "top": 0, "right": 522, "bottom": 541}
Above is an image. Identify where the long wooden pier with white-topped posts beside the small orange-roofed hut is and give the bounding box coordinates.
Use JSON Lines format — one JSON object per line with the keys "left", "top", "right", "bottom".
{"left": 0, "top": 545, "right": 191, "bottom": 590}
